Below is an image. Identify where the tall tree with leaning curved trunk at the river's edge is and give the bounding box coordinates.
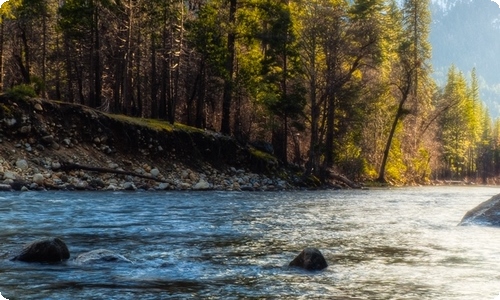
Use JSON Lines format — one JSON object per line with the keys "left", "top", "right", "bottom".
{"left": 378, "top": 0, "right": 434, "bottom": 182}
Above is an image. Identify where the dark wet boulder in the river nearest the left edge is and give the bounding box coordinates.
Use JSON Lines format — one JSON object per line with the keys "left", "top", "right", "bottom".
{"left": 12, "top": 238, "right": 70, "bottom": 262}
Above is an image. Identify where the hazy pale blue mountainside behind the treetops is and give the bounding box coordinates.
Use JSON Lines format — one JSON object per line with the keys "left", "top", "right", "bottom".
{"left": 430, "top": 0, "right": 500, "bottom": 118}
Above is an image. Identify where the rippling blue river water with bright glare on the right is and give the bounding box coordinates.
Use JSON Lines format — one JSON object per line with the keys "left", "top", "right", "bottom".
{"left": 0, "top": 187, "right": 500, "bottom": 300}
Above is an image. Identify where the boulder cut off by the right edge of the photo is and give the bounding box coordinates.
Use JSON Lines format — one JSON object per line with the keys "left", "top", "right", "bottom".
{"left": 459, "top": 195, "right": 500, "bottom": 226}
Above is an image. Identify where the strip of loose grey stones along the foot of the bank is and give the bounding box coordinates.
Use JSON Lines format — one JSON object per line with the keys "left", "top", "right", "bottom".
{"left": 0, "top": 158, "right": 297, "bottom": 191}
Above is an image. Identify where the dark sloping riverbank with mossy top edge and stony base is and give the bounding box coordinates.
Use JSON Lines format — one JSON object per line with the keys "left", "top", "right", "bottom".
{"left": 0, "top": 96, "right": 332, "bottom": 191}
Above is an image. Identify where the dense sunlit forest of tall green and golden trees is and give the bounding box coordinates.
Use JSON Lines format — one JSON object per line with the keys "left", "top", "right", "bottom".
{"left": 0, "top": 0, "right": 500, "bottom": 184}
